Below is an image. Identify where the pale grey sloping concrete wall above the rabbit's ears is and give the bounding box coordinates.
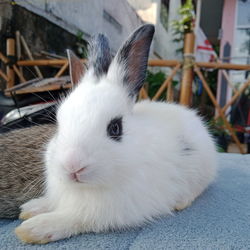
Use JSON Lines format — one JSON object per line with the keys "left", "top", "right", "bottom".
{"left": 17, "top": 0, "right": 142, "bottom": 51}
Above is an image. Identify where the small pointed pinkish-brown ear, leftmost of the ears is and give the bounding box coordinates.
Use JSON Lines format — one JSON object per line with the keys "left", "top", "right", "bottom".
{"left": 67, "top": 49, "right": 84, "bottom": 84}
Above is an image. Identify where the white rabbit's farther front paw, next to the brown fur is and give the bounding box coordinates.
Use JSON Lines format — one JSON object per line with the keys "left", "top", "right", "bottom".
{"left": 19, "top": 197, "right": 49, "bottom": 220}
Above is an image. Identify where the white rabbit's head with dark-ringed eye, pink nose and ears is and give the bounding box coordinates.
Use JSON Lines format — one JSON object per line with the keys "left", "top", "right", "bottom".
{"left": 47, "top": 24, "right": 154, "bottom": 186}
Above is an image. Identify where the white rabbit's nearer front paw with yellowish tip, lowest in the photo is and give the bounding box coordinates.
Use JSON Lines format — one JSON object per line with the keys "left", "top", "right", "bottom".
{"left": 15, "top": 213, "right": 67, "bottom": 244}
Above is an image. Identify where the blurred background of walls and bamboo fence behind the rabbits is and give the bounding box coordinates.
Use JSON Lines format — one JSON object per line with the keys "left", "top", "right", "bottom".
{"left": 0, "top": 0, "right": 250, "bottom": 153}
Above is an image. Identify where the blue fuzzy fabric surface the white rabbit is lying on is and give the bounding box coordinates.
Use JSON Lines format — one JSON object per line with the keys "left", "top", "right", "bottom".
{"left": 0, "top": 154, "right": 250, "bottom": 250}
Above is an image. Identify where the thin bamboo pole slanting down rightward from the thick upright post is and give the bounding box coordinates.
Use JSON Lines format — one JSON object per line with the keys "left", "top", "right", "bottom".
{"left": 194, "top": 65, "right": 245, "bottom": 154}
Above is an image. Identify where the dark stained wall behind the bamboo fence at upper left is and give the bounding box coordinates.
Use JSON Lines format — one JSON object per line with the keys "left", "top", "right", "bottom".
{"left": 0, "top": 1, "right": 86, "bottom": 89}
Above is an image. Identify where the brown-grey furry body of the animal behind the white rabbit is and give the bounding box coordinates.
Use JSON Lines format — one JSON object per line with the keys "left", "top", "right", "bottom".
{"left": 0, "top": 125, "right": 54, "bottom": 218}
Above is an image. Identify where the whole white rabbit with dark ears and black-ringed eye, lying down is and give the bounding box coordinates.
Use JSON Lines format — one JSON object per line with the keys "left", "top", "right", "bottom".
{"left": 16, "top": 24, "right": 216, "bottom": 243}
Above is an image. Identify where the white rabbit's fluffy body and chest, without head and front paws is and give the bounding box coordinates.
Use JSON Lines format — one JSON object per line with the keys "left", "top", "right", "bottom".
{"left": 44, "top": 101, "right": 216, "bottom": 232}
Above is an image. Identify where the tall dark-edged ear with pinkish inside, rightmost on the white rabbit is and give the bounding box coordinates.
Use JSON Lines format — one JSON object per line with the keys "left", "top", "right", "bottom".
{"left": 115, "top": 24, "right": 155, "bottom": 97}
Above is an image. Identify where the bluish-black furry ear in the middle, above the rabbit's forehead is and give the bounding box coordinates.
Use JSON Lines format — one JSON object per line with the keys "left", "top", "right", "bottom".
{"left": 88, "top": 34, "right": 112, "bottom": 77}
